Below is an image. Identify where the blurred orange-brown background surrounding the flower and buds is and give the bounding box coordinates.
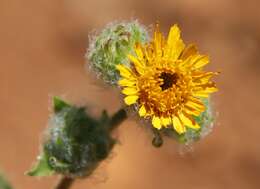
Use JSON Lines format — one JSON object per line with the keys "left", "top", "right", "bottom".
{"left": 0, "top": 0, "right": 260, "bottom": 189}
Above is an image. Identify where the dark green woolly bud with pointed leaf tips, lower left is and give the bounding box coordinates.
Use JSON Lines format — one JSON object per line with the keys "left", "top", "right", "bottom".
{"left": 27, "top": 97, "right": 126, "bottom": 177}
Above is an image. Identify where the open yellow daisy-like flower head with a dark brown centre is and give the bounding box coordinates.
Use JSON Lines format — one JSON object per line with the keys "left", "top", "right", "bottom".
{"left": 117, "top": 24, "right": 218, "bottom": 134}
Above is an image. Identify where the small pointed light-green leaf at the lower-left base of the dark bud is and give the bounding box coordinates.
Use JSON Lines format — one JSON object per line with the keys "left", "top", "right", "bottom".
{"left": 25, "top": 152, "right": 54, "bottom": 177}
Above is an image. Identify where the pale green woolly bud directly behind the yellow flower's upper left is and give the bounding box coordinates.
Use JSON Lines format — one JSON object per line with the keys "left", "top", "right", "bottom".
{"left": 86, "top": 21, "right": 148, "bottom": 84}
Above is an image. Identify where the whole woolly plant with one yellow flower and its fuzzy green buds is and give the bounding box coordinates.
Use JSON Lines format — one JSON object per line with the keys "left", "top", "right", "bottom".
{"left": 27, "top": 21, "right": 218, "bottom": 188}
